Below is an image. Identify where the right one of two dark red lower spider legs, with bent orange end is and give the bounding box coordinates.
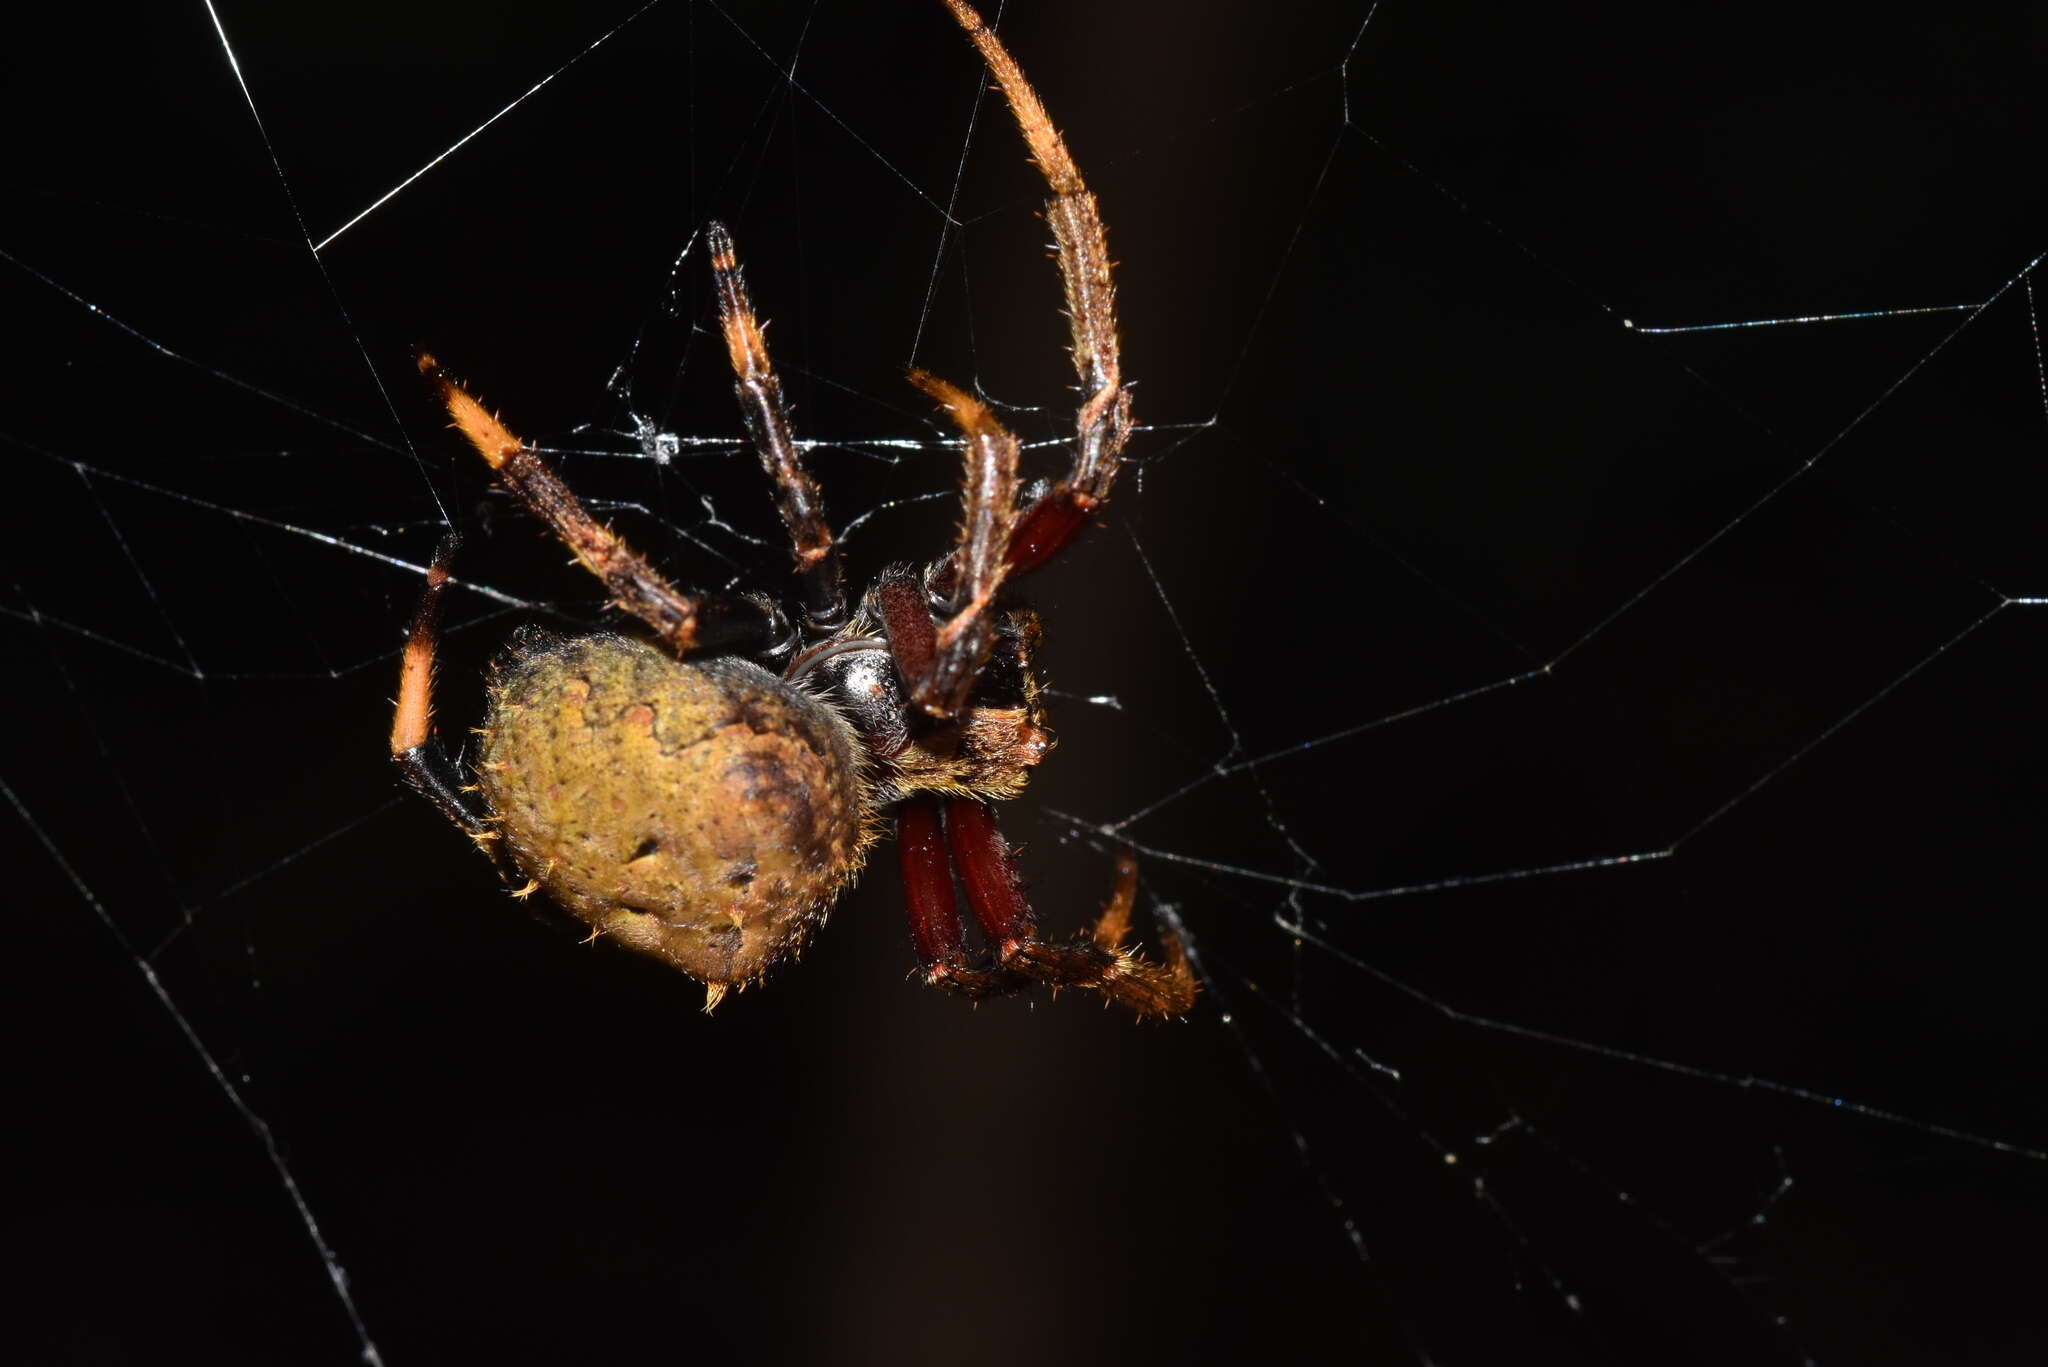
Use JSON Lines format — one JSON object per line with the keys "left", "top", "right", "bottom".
{"left": 946, "top": 797, "right": 1200, "bottom": 1017}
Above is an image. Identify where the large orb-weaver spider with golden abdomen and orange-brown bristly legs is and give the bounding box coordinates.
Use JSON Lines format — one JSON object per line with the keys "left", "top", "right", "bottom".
{"left": 391, "top": 0, "right": 1196, "bottom": 1017}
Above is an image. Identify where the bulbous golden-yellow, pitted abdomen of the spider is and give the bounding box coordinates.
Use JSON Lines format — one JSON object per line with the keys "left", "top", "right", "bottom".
{"left": 477, "top": 635, "right": 872, "bottom": 996}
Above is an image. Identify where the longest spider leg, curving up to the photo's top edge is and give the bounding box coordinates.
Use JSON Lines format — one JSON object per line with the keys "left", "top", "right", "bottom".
{"left": 946, "top": 0, "right": 1130, "bottom": 574}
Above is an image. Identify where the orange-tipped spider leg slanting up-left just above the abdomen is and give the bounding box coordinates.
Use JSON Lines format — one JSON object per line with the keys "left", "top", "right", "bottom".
{"left": 420, "top": 353, "right": 788, "bottom": 656}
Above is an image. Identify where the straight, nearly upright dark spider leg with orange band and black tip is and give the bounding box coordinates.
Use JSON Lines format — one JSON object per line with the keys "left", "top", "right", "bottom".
{"left": 705, "top": 221, "right": 846, "bottom": 631}
